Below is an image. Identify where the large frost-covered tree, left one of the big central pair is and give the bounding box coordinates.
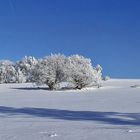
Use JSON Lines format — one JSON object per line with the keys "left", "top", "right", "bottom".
{"left": 33, "top": 54, "right": 67, "bottom": 90}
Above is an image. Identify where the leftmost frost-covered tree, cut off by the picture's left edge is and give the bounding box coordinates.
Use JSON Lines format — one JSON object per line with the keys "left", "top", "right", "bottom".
{"left": 0, "top": 60, "right": 16, "bottom": 83}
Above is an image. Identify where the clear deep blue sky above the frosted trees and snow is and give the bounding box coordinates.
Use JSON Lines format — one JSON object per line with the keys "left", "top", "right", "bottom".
{"left": 0, "top": 0, "right": 140, "bottom": 78}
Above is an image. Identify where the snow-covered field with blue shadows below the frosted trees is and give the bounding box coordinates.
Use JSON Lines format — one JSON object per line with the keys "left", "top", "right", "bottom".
{"left": 0, "top": 79, "right": 140, "bottom": 140}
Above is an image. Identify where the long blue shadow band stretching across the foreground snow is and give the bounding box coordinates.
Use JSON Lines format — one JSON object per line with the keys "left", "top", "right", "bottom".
{"left": 0, "top": 106, "right": 140, "bottom": 126}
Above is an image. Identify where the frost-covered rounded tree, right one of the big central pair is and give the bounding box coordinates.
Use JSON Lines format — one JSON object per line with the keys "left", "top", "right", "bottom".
{"left": 67, "top": 55, "right": 95, "bottom": 89}
